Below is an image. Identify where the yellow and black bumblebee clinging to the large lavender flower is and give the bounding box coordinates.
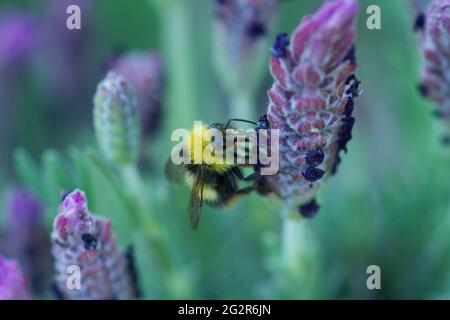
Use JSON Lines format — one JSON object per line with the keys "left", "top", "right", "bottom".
{"left": 165, "top": 119, "right": 267, "bottom": 229}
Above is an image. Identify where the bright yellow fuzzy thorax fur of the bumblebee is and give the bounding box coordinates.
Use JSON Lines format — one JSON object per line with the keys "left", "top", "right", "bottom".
{"left": 185, "top": 125, "right": 232, "bottom": 173}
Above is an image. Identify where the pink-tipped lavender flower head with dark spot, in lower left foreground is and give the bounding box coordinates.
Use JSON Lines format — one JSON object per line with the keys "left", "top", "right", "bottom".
{"left": 52, "top": 190, "right": 135, "bottom": 300}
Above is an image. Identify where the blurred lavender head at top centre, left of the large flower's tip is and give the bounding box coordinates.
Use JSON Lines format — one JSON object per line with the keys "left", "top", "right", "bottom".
{"left": 214, "top": 0, "right": 278, "bottom": 92}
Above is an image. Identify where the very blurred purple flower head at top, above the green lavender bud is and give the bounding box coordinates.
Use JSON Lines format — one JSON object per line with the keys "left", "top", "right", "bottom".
{"left": 34, "top": 0, "right": 97, "bottom": 104}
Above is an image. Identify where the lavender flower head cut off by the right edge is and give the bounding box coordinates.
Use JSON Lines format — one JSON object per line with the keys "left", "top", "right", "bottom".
{"left": 419, "top": 0, "right": 450, "bottom": 141}
